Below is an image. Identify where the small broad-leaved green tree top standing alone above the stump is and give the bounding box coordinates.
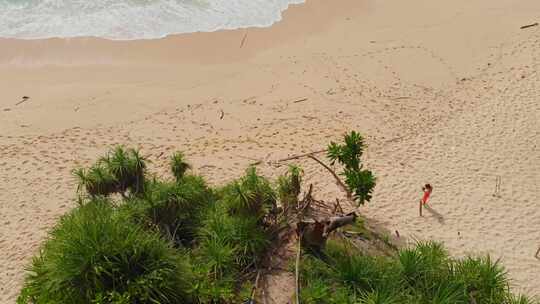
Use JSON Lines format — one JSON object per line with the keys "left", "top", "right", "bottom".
{"left": 327, "top": 131, "right": 376, "bottom": 205}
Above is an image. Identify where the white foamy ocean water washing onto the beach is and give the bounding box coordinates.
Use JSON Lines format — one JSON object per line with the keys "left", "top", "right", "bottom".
{"left": 0, "top": 0, "right": 304, "bottom": 40}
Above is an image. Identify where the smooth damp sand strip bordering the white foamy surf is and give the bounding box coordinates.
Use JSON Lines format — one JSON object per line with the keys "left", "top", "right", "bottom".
{"left": 0, "top": 0, "right": 338, "bottom": 67}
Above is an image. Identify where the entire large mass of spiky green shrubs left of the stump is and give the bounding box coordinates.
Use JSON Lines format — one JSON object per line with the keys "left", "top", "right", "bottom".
{"left": 18, "top": 147, "right": 282, "bottom": 304}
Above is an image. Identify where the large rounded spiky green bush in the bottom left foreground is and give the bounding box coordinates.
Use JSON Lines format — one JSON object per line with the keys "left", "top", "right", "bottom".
{"left": 18, "top": 200, "right": 192, "bottom": 304}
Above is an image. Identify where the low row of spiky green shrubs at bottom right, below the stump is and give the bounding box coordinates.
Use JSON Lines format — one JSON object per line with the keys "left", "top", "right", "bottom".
{"left": 300, "top": 240, "right": 536, "bottom": 304}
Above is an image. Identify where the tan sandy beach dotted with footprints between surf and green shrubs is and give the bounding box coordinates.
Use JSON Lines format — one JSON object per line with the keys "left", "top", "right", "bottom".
{"left": 0, "top": 0, "right": 540, "bottom": 304}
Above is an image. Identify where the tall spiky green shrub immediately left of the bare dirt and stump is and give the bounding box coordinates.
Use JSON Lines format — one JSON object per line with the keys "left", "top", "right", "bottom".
{"left": 193, "top": 168, "right": 276, "bottom": 303}
